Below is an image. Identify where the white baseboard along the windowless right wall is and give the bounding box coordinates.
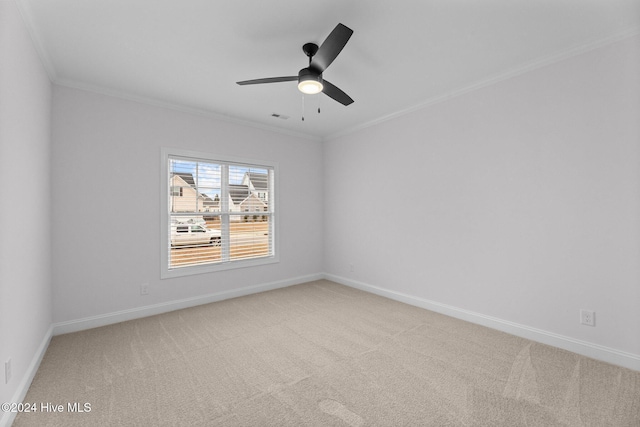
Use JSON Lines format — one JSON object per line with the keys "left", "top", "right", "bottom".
{"left": 324, "top": 274, "right": 640, "bottom": 371}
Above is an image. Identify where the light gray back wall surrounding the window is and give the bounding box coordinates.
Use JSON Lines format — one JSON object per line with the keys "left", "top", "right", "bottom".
{"left": 52, "top": 86, "right": 323, "bottom": 322}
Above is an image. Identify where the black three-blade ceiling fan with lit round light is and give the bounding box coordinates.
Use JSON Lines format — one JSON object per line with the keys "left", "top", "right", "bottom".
{"left": 237, "top": 24, "right": 353, "bottom": 105}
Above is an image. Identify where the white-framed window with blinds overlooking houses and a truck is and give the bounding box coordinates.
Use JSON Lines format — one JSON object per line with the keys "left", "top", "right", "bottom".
{"left": 161, "top": 149, "right": 278, "bottom": 278}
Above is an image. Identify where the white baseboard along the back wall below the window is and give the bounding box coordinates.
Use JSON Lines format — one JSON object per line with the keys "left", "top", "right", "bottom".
{"left": 53, "top": 273, "right": 324, "bottom": 335}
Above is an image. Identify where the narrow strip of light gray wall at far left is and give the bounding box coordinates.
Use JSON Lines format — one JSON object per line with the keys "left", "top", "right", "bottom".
{"left": 0, "top": 1, "right": 51, "bottom": 412}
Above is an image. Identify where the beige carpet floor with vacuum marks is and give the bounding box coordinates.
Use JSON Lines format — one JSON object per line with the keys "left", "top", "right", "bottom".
{"left": 14, "top": 280, "right": 640, "bottom": 427}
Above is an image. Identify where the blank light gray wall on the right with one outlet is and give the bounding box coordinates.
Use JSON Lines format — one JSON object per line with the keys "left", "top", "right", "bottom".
{"left": 324, "top": 37, "right": 640, "bottom": 357}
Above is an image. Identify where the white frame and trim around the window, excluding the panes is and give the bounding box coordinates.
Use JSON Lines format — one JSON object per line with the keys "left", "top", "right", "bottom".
{"left": 160, "top": 147, "right": 280, "bottom": 279}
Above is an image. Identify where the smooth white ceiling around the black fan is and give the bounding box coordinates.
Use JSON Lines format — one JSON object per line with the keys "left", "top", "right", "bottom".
{"left": 16, "top": 0, "right": 640, "bottom": 139}
